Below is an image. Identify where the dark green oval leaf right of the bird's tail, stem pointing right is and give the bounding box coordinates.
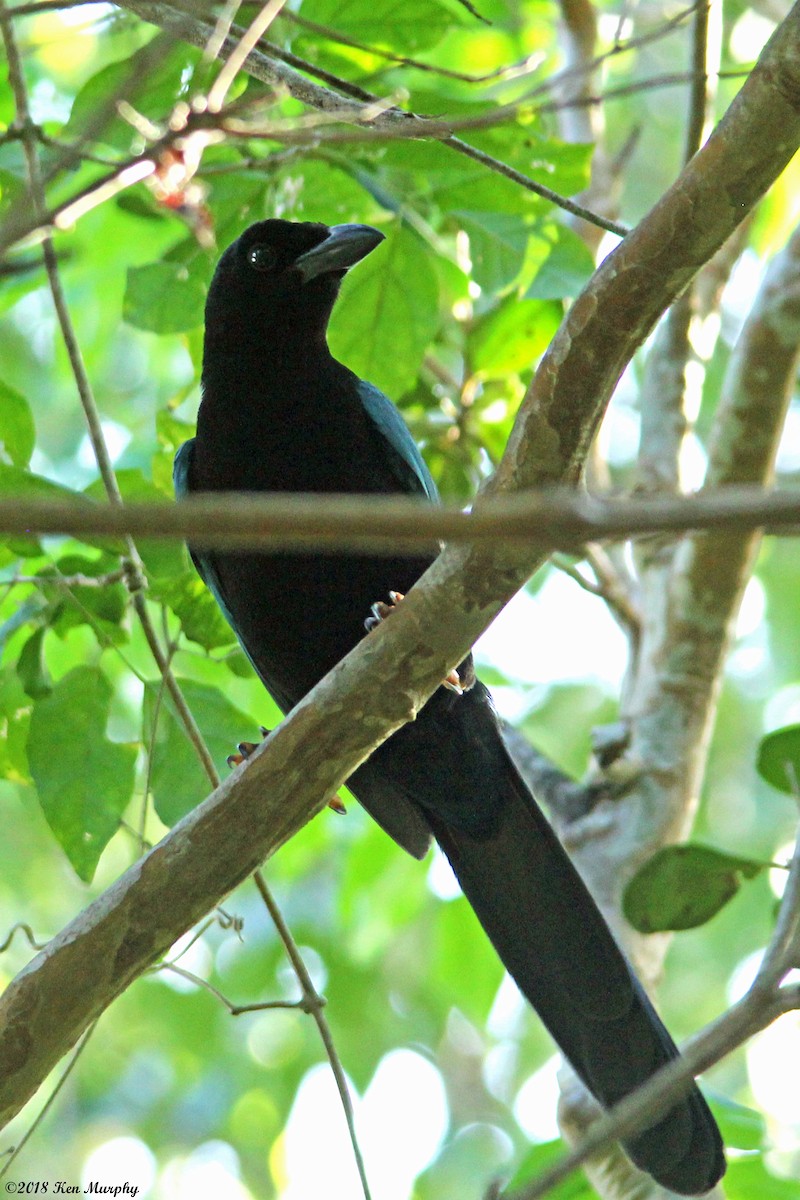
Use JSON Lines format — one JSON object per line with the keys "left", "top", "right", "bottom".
{"left": 622, "top": 842, "right": 771, "bottom": 934}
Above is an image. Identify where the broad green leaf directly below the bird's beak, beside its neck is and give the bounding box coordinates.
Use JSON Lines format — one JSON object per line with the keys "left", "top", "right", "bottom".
{"left": 330, "top": 224, "right": 439, "bottom": 400}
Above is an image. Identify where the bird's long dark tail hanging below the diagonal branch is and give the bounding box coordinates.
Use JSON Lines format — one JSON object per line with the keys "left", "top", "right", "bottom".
{"left": 426, "top": 761, "right": 724, "bottom": 1195}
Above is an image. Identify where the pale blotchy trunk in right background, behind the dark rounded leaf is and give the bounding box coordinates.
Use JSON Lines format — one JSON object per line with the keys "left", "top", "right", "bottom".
{"left": 554, "top": 93, "right": 800, "bottom": 1200}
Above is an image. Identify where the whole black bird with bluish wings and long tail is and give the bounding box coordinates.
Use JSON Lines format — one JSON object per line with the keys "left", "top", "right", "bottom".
{"left": 175, "top": 221, "right": 724, "bottom": 1195}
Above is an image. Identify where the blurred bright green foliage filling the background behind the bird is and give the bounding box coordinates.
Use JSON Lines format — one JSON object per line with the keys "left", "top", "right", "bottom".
{"left": 0, "top": 0, "right": 800, "bottom": 1200}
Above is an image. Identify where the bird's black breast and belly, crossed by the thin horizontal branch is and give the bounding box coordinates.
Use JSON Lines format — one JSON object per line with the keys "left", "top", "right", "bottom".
{"left": 187, "top": 359, "right": 441, "bottom": 709}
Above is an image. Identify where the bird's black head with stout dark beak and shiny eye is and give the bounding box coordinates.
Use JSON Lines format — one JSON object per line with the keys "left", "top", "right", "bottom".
{"left": 205, "top": 221, "right": 384, "bottom": 352}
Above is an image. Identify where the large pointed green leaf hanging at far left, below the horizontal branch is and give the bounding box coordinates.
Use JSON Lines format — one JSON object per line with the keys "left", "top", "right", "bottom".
{"left": 28, "top": 666, "right": 137, "bottom": 883}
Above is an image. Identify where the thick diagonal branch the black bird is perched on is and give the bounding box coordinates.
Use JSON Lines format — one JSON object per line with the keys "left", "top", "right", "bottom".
{"left": 0, "top": 0, "right": 800, "bottom": 1142}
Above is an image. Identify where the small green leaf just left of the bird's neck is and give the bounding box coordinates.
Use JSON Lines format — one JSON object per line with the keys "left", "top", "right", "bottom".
{"left": 122, "top": 263, "right": 205, "bottom": 334}
